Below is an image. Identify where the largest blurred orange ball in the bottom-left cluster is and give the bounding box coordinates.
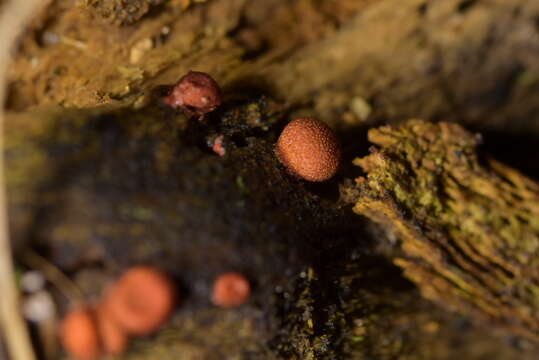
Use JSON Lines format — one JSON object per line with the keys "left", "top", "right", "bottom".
{"left": 103, "top": 266, "right": 176, "bottom": 335}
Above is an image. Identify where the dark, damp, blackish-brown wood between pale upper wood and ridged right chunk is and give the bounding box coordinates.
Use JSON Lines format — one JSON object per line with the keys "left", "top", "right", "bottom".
{"left": 6, "top": 100, "right": 535, "bottom": 360}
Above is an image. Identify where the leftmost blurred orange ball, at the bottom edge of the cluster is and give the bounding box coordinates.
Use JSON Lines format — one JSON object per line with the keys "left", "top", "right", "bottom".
{"left": 60, "top": 307, "right": 101, "bottom": 360}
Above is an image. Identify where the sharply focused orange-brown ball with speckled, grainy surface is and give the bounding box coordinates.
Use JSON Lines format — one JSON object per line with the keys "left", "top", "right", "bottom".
{"left": 276, "top": 117, "right": 341, "bottom": 182}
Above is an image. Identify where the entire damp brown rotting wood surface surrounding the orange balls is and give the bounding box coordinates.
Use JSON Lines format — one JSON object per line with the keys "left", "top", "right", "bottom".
{"left": 6, "top": 0, "right": 539, "bottom": 360}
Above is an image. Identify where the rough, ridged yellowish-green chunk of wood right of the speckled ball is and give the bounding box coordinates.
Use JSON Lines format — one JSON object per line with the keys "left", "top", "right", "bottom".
{"left": 344, "top": 120, "right": 539, "bottom": 341}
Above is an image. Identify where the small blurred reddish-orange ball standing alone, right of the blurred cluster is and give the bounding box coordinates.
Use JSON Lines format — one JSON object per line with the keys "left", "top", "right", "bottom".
{"left": 212, "top": 272, "right": 251, "bottom": 308}
